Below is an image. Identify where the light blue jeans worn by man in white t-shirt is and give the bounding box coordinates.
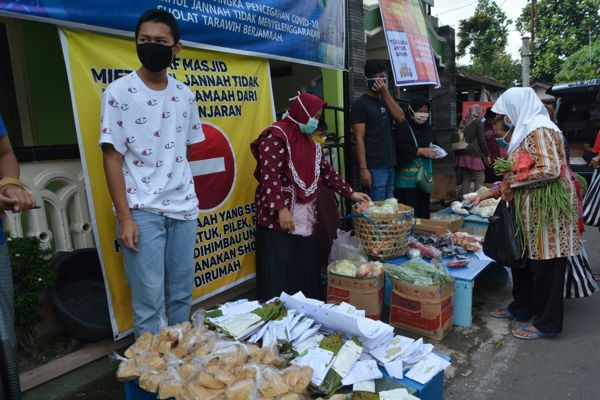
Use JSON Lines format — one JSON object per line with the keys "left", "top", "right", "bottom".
{"left": 117, "top": 210, "right": 197, "bottom": 337}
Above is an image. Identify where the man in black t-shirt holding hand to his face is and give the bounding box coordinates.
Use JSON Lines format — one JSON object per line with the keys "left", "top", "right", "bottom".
{"left": 351, "top": 60, "right": 404, "bottom": 201}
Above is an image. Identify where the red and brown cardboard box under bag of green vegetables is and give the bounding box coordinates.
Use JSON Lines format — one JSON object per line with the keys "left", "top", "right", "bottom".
{"left": 389, "top": 277, "right": 454, "bottom": 340}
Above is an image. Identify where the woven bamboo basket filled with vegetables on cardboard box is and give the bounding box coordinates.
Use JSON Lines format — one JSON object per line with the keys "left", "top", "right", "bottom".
{"left": 352, "top": 201, "right": 414, "bottom": 260}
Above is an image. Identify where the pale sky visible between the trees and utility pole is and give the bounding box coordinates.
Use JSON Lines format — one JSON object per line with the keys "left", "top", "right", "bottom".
{"left": 431, "top": 0, "right": 527, "bottom": 64}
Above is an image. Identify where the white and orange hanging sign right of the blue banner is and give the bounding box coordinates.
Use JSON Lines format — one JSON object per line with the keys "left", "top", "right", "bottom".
{"left": 379, "top": 0, "right": 440, "bottom": 87}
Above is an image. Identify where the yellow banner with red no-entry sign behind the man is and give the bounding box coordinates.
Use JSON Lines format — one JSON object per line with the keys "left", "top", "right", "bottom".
{"left": 61, "top": 30, "right": 274, "bottom": 339}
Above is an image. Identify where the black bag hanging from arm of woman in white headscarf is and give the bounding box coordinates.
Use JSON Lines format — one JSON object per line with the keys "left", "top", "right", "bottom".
{"left": 483, "top": 200, "right": 525, "bottom": 268}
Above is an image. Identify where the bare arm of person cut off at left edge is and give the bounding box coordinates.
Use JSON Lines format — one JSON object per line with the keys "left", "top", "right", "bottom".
{"left": 0, "top": 135, "right": 35, "bottom": 212}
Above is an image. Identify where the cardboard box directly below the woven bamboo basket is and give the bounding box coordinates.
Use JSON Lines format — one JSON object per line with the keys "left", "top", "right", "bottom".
{"left": 327, "top": 265, "right": 384, "bottom": 320}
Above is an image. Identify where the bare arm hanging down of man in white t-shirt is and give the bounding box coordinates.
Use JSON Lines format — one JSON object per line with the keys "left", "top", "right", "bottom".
{"left": 102, "top": 143, "right": 139, "bottom": 252}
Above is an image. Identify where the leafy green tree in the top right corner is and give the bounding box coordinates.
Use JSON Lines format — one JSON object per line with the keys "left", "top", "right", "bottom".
{"left": 516, "top": 0, "right": 600, "bottom": 82}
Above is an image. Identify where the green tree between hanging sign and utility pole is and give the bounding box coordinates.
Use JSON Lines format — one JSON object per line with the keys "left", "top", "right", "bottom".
{"left": 458, "top": 0, "right": 512, "bottom": 65}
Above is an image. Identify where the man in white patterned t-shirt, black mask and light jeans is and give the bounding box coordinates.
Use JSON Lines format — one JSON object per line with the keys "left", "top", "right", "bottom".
{"left": 100, "top": 9, "right": 204, "bottom": 337}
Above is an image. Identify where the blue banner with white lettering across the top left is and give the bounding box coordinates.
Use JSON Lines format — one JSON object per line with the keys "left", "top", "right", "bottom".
{"left": 0, "top": 0, "right": 346, "bottom": 69}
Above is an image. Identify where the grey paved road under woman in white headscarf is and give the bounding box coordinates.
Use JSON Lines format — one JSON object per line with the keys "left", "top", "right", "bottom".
{"left": 445, "top": 230, "right": 600, "bottom": 400}
